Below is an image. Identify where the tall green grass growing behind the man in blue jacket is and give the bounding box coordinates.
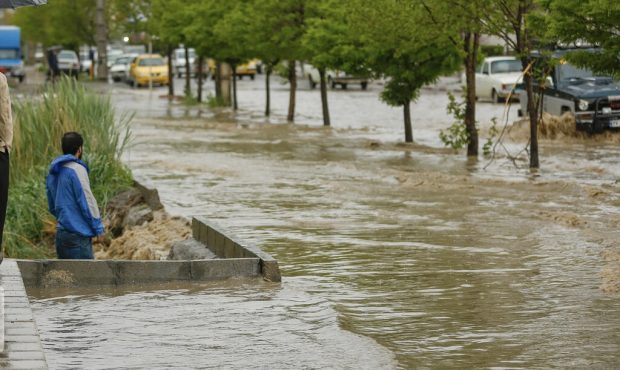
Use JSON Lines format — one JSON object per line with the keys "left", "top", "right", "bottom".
{"left": 4, "top": 78, "right": 132, "bottom": 258}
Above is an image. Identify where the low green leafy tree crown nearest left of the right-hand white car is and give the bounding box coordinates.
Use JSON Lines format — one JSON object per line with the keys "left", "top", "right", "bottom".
{"left": 347, "top": 0, "right": 461, "bottom": 105}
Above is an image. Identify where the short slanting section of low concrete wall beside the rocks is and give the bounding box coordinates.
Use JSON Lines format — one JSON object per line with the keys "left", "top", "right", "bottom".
{"left": 192, "top": 217, "right": 282, "bottom": 282}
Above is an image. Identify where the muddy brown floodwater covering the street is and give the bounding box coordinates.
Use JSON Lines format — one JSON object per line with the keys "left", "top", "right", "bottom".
{"left": 33, "top": 76, "right": 620, "bottom": 369}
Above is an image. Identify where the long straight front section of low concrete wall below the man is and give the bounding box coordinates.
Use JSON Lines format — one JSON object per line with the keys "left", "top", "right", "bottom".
{"left": 17, "top": 257, "right": 261, "bottom": 288}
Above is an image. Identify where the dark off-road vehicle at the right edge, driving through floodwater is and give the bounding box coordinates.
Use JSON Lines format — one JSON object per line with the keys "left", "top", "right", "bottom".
{"left": 519, "top": 49, "right": 620, "bottom": 133}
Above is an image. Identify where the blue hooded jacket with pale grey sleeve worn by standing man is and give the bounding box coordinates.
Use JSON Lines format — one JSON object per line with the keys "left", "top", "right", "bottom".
{"left": 45, "top": 154, "right": 103, "bottom": 237}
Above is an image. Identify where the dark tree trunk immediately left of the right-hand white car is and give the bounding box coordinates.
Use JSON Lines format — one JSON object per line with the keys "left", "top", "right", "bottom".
{"left": 464, "top": 32, "right": 480, "bottom": 157}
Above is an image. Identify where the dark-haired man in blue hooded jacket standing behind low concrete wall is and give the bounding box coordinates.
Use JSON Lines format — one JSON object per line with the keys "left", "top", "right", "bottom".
{"left": 46, "top": 132, "right": 104, "bottom": 259}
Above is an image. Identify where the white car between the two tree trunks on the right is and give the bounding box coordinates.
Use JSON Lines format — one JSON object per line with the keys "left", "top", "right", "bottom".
{"left": 476, "top": 56, "right": 523, "bottom": 103}
